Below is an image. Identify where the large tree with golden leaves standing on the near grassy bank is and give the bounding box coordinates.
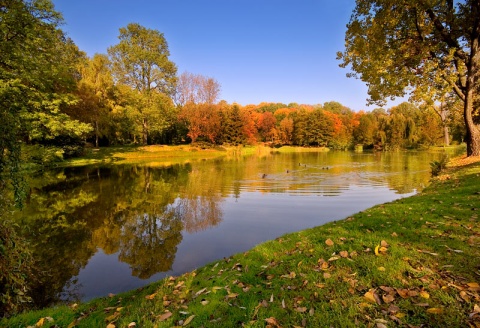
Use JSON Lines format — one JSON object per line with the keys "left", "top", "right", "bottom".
{"left": 338, "top": 0, "right": 480, "bottom": 156}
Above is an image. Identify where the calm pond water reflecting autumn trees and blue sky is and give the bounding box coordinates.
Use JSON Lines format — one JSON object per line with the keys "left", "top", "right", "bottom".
{"left": 18, "top": 152, "right": 441, "bottom": 304}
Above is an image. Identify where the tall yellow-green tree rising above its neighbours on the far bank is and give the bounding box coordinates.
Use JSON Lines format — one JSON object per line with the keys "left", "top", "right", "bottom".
{"left": 108, "top": 23, "right": 177, "bottom": 144}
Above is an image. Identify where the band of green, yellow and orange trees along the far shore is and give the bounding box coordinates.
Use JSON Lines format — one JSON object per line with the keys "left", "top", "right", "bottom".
{"left": 0, "top": 0, "right": 464, "bottom": 166}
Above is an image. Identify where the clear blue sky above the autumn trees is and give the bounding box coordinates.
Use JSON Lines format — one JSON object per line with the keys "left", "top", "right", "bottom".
{"left": 53, "top": 0, "right": 390, "bottom": 111}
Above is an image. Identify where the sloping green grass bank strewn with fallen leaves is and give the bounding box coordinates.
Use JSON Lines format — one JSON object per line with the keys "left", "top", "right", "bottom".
{"left": 0, "top": 155, "right": 480, "bottom": 327}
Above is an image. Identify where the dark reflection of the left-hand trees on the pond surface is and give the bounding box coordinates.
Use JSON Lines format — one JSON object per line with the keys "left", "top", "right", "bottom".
{"left": 16, "top": 165, "right": 222, "bottom": 306}
